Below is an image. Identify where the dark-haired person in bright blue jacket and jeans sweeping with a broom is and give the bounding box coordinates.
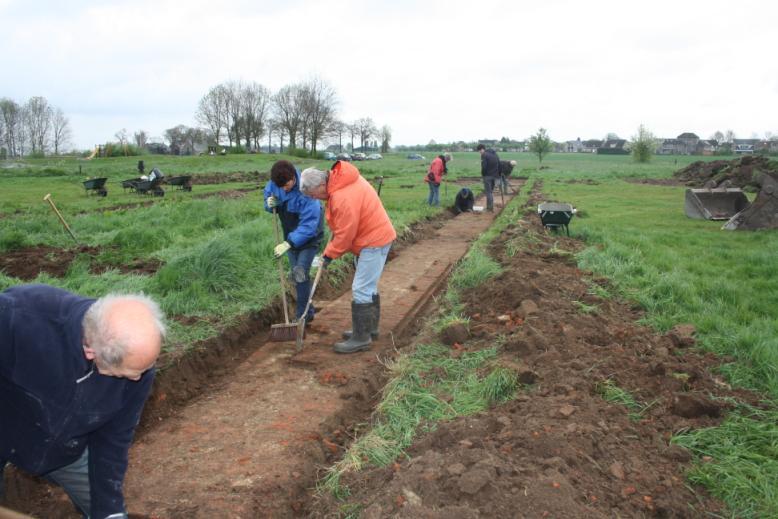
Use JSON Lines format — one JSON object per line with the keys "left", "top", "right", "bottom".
{"left": 265, "top": 160, "right": 324, "bottom": 322}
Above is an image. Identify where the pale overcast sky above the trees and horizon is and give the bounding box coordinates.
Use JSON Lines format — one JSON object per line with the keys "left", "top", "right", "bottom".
{"left": 0, "top": 0, "right": 778, "bottom": 148}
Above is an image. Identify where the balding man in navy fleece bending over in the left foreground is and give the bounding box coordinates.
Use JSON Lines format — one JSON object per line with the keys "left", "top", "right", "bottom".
{"left": 0, "top": 285, "right": 165, "bottom": 519}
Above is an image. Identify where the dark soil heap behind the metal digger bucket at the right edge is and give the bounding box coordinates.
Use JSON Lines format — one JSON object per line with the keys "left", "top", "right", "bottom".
{"left": 673, "top": 155, "right": 778, "bottom": 191}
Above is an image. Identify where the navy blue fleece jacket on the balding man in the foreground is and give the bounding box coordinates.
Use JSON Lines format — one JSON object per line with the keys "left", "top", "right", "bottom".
{"left": 0, "top": 285, "right": 154, "bottom": 517}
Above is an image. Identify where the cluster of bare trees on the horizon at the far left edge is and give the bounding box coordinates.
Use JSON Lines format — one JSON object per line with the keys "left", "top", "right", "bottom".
{"left": 0, "top": 96, "right": 71, "bottom": 157}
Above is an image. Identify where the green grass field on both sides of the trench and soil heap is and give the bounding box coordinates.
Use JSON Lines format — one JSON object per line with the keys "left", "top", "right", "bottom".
{"left": 0, "top": 152, "right": 778, "bottom": 517}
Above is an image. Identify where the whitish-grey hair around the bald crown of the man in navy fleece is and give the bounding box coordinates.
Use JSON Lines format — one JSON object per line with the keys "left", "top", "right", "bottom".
{"left": 83, "top": 294, "right": 167, "bottom": 367}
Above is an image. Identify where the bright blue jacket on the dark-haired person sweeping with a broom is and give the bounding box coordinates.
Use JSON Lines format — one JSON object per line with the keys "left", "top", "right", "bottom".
{"left": 264, "top": 171, "right": 324, "bottom": 250}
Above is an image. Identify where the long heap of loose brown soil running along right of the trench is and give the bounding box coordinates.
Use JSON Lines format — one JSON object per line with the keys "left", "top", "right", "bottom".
{"left": 317, "top": 189, "right": 756, "bottom": 518}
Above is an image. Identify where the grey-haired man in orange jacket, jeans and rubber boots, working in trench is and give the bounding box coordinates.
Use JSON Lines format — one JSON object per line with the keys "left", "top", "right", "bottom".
{"left": 300, "top": 161, "right": 397, "bottom": 353}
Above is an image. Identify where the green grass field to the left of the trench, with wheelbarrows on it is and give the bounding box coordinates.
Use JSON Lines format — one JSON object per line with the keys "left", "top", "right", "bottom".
{"left": 0, "top": 154, "right": 478, "bottom": 352}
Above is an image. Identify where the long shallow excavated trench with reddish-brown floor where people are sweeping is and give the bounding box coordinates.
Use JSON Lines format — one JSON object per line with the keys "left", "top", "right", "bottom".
{"left": 7, "top": 179, "right": 523, "bottom": 517}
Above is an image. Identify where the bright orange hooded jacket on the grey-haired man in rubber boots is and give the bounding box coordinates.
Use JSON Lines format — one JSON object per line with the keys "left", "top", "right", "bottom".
{"left": 324, "top": 161, "right": 397, "bottom": 259}
